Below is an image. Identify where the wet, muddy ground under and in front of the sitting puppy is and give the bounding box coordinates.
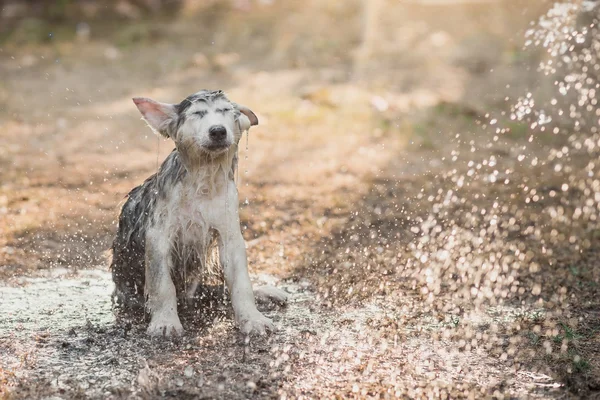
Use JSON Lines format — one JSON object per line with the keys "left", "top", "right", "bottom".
{"left": 0, "top": 270, "right": 576, "bottom": 398}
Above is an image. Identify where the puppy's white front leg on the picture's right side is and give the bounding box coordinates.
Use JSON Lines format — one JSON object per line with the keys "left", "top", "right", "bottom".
{"left": 219, "top": 231, "right": 275, "bottom": 335}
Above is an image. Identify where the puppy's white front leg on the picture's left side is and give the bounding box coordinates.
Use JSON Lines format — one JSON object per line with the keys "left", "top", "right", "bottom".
{"left": 145, "top": 232, "right": 183, "bottom": 336}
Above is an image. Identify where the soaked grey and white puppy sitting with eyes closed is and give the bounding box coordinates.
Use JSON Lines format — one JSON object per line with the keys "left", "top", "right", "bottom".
{"left": 111, "top": 90, "right": 287, "bottom": 336}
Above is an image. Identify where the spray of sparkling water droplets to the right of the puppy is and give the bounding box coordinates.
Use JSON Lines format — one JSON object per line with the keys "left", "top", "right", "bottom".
{"left": 292, "top": 3, "right": 600, "bottom": 398}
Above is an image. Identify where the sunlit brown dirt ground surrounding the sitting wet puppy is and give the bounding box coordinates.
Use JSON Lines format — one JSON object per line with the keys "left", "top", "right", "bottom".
{"left": 0, "top": 0, "right": 600, "bottom": 399}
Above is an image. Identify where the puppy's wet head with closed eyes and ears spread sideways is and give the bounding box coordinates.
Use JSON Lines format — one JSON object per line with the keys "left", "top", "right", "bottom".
{"left": 133, "top": 90, "right": 258, "bottom": 158}
